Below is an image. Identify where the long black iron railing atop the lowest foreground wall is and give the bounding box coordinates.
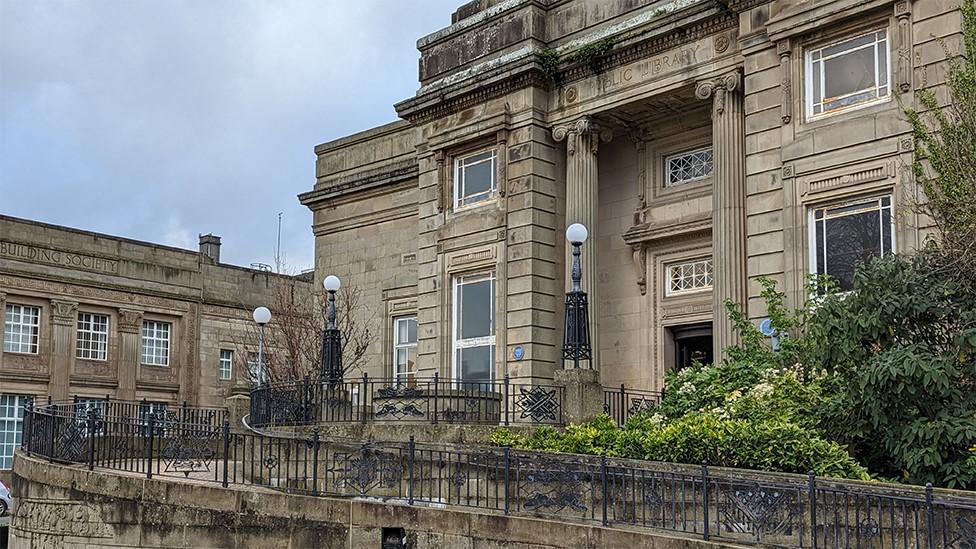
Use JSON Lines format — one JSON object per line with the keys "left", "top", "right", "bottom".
{"left": 17, "top": 398, "right": 976, "bottom": 549}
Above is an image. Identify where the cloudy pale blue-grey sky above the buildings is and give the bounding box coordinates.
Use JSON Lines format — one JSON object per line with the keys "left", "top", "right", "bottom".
{"left": 0, "top": 0, "right": 464, "bottom": 272}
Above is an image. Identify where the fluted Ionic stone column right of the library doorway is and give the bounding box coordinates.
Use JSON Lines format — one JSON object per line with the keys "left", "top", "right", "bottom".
{"left": 695, "top": 70, "right": 747, "bottom": 361}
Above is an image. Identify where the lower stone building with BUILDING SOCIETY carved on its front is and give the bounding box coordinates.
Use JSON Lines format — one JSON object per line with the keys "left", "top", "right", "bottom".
{"left": 0, "top": 216, "right": 308, "bottom": 476}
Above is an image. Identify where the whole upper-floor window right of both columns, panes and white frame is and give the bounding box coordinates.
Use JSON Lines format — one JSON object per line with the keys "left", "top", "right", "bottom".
{"left": 806, "top": 30, "right": 889, "bottom": 118}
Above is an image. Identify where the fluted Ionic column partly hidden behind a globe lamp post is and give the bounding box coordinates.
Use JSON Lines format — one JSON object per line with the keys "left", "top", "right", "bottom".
{"left": 552, "top": 116, "right": 613, "bottom": 368}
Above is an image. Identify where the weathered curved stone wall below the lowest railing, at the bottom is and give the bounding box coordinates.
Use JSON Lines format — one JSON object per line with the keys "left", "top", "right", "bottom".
{"left": 10, "top": 454, "right": 731, "bottom": 549}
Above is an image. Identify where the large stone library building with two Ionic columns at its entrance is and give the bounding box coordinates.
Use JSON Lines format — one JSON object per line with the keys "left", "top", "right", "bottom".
{"left": 300, "top": 0, "right": 948, "bottom": 389}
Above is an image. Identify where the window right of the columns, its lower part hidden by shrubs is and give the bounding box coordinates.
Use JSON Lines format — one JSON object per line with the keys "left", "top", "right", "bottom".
{"left": 810, "top": 196, "right": 895, "bottom": 290}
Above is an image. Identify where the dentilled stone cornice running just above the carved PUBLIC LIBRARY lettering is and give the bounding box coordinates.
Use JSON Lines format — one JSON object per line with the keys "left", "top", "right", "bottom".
{"left": 394, "top": 3, "right": 738, "bottom": 124}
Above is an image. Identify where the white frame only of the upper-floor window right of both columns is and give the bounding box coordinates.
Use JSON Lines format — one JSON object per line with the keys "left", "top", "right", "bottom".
{"left": 803, "top": 27, "right": 891, "bottom": 120}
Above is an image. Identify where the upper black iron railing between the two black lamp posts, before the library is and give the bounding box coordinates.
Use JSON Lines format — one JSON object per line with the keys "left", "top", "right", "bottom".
{"left": 249, "top": 375, "right": 565, "bottom": 427}
